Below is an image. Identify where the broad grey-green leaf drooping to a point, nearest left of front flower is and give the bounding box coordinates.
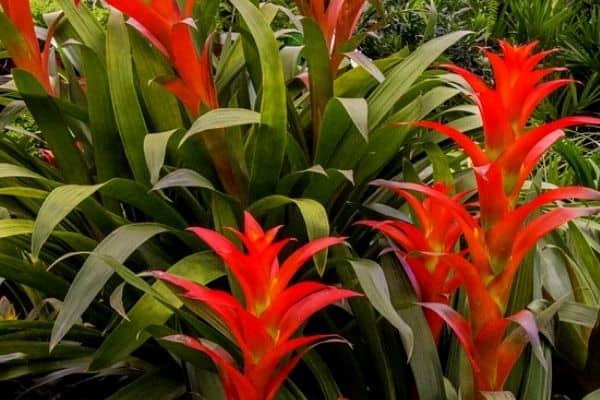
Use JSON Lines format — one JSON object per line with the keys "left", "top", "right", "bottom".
{"left": 50, "top": 223, "right": 166, "bottom": 350}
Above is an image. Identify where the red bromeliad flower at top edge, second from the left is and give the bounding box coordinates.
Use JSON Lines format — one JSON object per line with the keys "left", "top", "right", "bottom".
{"left": 101, "top": 0, "right": 218, "bottom": 117}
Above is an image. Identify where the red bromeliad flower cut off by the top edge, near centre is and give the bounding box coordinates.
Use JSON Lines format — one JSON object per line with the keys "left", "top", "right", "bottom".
{"left": 296, "top": 0, "right": 366, "bottom": 76}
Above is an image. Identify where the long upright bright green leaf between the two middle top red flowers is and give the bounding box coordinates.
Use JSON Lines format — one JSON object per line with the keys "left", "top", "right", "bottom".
{"left": 231, "top": 0, "right": 287, "bottom": 199}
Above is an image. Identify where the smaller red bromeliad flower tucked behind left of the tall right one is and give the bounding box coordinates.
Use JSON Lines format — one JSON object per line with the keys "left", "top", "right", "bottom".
{"left": 359, "top": 182, "right": 466, "bottom": 341}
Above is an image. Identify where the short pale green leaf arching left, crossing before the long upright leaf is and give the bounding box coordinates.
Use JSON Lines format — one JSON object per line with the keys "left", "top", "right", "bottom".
{"left": 179, "top": 108, "right": 261, "bottom": 146}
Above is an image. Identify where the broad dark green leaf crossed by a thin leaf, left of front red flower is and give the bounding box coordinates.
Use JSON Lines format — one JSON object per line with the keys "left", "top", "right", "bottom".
{"left": 89, "top": 252, "right": 224, "bottom": 371}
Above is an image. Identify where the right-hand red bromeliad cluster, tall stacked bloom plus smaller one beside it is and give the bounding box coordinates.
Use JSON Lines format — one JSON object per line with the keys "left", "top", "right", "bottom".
{"left": 366, "top": 42, "right": 600, "bottom": 397}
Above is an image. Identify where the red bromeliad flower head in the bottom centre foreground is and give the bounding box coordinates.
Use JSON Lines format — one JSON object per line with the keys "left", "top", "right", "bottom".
{"left": 154, "top": 213, "right": 358, "bottom": 400}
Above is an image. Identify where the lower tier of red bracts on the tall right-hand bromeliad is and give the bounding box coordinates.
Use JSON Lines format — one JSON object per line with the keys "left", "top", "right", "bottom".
{"left": 373, "top": 180, "right": 600, "bottom": 391}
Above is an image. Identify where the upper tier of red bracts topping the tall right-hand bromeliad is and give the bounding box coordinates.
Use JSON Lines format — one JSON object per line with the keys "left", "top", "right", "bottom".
{"left": 406, "top": 41, "right": 600, "bottom": 230}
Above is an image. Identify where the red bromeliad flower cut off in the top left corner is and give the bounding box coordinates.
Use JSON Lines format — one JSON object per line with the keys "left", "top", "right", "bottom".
{"left": 0, "top": 0, "right": 54, "bottom": 94}
